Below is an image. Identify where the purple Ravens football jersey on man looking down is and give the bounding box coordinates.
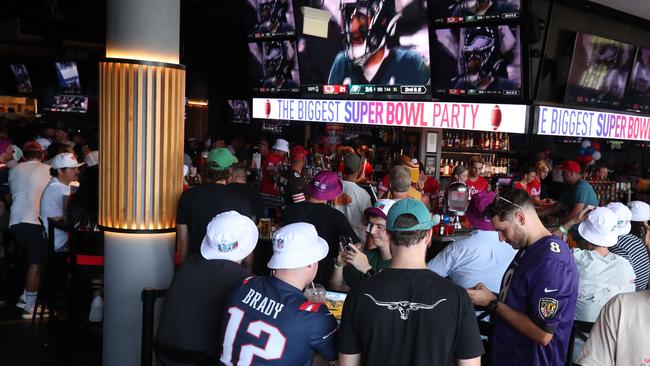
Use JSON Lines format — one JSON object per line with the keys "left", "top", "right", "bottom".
{"left": 492, "top": 236, "right": 578, "bottom": 366}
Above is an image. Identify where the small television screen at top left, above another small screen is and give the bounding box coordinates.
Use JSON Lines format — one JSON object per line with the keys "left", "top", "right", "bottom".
{"left": 246, "top": 0, "right": 296, "bottom": 40}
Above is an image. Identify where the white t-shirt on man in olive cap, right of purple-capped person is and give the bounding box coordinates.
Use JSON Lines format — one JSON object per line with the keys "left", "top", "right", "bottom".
{"left": 334, "top": 180, "right": 372, "bottom": 243}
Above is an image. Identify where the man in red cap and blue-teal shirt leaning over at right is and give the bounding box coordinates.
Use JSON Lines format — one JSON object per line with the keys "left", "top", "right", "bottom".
{"left": 540, "top": 160, "right": 598, "bottom": 235}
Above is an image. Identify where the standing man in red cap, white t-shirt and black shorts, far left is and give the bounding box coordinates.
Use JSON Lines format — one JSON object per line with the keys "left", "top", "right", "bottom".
{"left": 9, "top": 141, "right": 51, "bottom": 318}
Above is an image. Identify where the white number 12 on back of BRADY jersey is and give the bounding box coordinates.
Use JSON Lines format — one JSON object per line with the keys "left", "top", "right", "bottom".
{"left": 221, "top": 306, "right": 287, "bottom": 366}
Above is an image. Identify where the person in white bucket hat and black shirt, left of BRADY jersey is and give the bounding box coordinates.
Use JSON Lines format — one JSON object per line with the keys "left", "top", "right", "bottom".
{"left": 156, "top": 211, "right": 258, "bottom": 366}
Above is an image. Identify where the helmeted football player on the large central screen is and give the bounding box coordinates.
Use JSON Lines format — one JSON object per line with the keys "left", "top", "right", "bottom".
{"left": 328, "top": 0, "right": 430, "bottom": 85}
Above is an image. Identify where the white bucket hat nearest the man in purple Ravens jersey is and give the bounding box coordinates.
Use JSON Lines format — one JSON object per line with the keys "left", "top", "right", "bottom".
{"left": 578, "top": 207, "right": 618, "bottom": 248}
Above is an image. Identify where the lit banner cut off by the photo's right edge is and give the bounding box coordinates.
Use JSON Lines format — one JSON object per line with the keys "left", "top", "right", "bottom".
{"left": 536, "top": 106, "right": 650, "bottom": 141}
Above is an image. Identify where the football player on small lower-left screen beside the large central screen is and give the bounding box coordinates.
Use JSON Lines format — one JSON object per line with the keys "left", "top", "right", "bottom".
{"left": 262, "top": 41, "right": 298, "bottom": 89}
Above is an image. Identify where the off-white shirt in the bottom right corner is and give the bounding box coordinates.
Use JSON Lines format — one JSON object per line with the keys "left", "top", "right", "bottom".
{"left": 576, "top": 291, "right": 650, "bottom": 366}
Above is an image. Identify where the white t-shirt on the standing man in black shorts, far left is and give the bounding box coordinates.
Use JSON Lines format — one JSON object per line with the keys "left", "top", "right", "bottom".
{"left": 9, "top": 160, "right": 51, "bottom": 226}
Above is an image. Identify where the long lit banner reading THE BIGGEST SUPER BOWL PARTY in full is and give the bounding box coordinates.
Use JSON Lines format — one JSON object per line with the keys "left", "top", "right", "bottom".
{"left": 253, "top": 98, "right": 527, "bottom": 133}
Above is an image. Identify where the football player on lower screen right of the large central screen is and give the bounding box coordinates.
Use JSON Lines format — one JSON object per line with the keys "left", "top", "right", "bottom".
{"left": 454, "top": 27, "right": 519, "bottom": 90}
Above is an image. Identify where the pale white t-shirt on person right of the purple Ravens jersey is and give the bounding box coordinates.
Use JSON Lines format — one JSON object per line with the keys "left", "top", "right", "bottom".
{"left": 573, "top": 249, "right": 636, "bottom": 322}
